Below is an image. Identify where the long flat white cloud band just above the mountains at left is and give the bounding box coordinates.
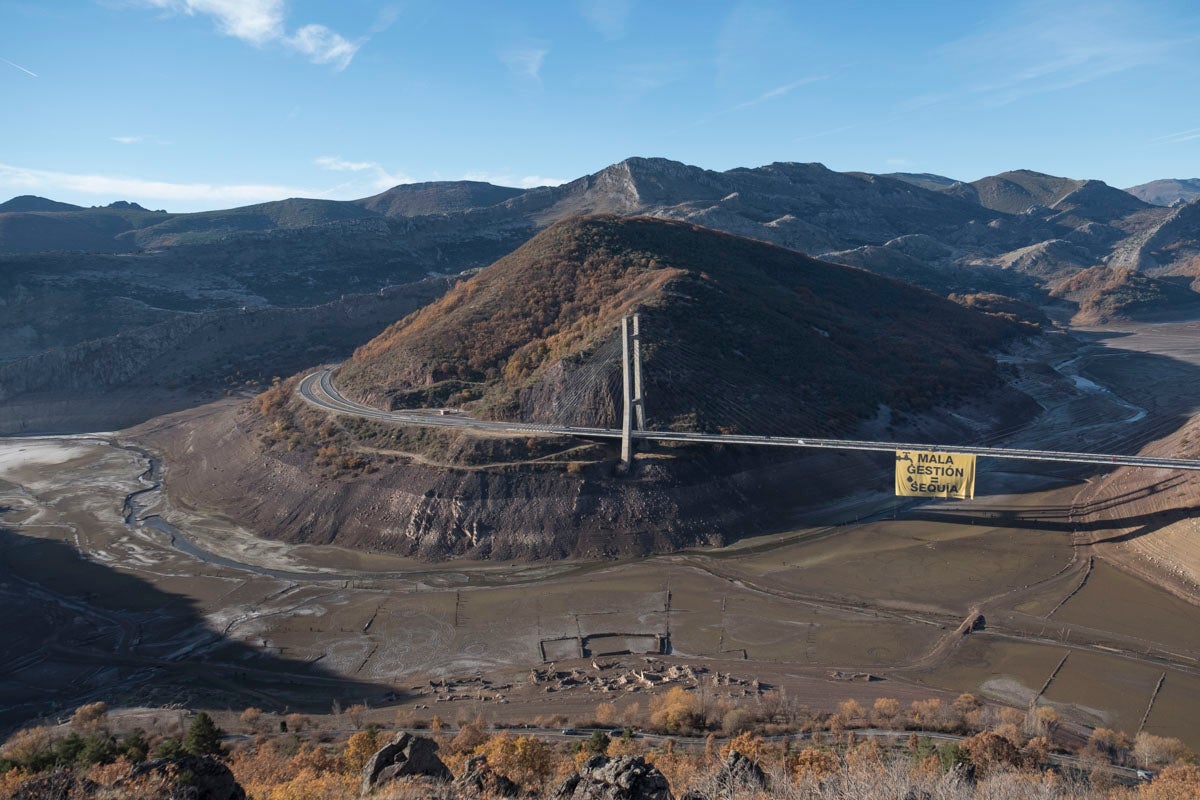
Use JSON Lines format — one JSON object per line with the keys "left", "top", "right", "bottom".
{"left": 0, "top": 163, "right": 323, "bottom": 206}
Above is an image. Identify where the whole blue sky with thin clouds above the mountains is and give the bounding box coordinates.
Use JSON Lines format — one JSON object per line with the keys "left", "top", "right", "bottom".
{"left": 0, "top": 0, "right": 1200, "bottom": 211}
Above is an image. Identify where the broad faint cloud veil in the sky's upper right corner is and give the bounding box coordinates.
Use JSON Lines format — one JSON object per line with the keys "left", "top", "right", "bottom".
{"left": 898, "top": 0, "right": 1196, "bottom": 112}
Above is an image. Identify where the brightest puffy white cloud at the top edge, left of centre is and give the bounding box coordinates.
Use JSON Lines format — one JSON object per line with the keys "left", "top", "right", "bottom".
{"left": 144, "top": 0, "right": 366, "bottom": 71}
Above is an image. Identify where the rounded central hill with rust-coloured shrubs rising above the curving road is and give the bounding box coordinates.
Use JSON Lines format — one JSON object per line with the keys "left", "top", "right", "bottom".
{"left": 336, "top": 216, "right": 1028, "bottom": 433}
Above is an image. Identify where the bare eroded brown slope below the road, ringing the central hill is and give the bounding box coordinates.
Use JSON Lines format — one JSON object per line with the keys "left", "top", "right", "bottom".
{"left": 144, "top": 409, "right": 844, "bottom": 560}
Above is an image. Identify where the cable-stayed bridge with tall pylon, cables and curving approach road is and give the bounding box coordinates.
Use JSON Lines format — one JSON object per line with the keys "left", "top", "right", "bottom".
{"left": 298, "top": 314, "right": 1200, "bottom": 470}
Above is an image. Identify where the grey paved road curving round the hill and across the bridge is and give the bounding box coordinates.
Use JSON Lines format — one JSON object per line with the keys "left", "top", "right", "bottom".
{"left": 298, "top": 367, "right": 1200, "bottom": 470}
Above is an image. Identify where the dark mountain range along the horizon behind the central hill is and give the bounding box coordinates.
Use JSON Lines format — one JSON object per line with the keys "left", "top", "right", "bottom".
{"left": 0, "top": 158, "right": 1200, "bottom": 431}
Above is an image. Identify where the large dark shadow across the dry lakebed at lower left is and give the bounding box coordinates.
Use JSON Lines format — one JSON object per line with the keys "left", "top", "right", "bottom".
{"left": 0, "top": 528, "right": 398, "bottom": 729}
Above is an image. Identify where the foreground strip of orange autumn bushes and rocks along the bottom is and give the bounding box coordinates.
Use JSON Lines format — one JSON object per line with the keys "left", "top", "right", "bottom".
{"left": 0, "top": 687, "right": 1200, "bottom": 800}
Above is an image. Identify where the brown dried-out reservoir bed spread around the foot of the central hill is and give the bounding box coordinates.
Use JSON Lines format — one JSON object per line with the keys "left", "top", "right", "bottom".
{"left": 7, "top": 326, "right": 1200, "bottom": 745}
